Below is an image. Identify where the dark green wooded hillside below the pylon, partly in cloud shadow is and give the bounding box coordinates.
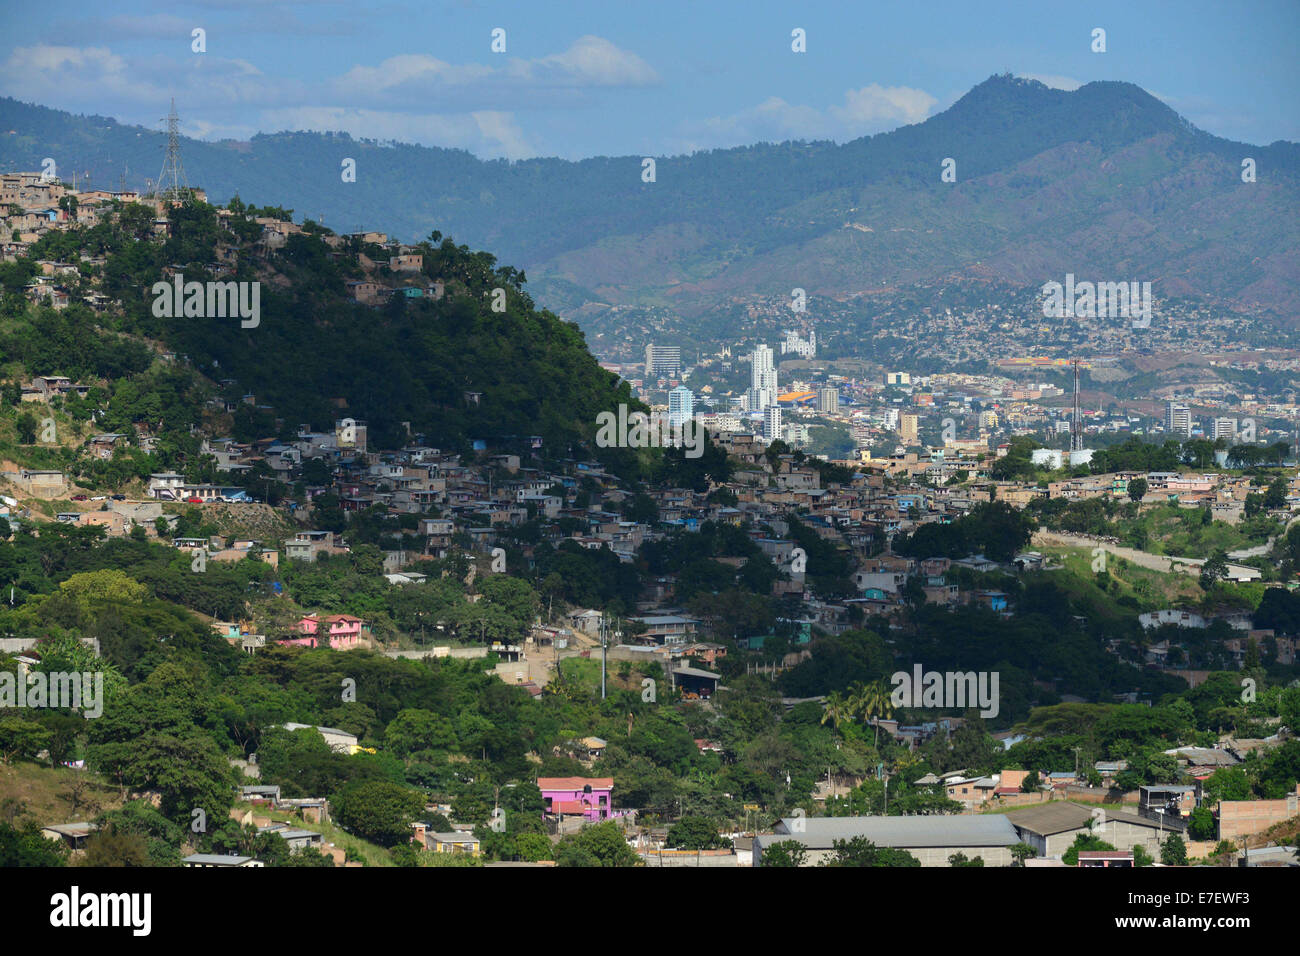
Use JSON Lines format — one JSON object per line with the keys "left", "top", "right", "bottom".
{"left": 0, "top": 200, "right": 647, "bottom": 479}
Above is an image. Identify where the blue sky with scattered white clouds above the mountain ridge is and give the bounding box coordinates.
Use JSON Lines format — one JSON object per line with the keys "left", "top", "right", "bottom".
{"left": 0, "top": 0, "right": 1300, "bottom": 159}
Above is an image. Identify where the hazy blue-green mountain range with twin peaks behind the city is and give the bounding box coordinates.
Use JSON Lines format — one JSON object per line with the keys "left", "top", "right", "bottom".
{"left": 0, "top": 75, "right": 1300, "bottom": 316}
